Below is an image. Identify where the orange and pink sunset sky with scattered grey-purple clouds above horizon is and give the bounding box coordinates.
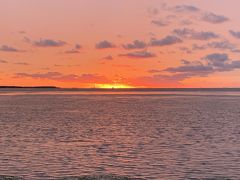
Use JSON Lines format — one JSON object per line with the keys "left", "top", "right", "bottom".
{"left": 0, "top": 0, "right": 240, "bottom": 88}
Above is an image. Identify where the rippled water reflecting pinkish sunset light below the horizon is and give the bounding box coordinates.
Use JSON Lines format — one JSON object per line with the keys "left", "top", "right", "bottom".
{"left": 0, "top": 92, "right": 240, "bottom": 180}
